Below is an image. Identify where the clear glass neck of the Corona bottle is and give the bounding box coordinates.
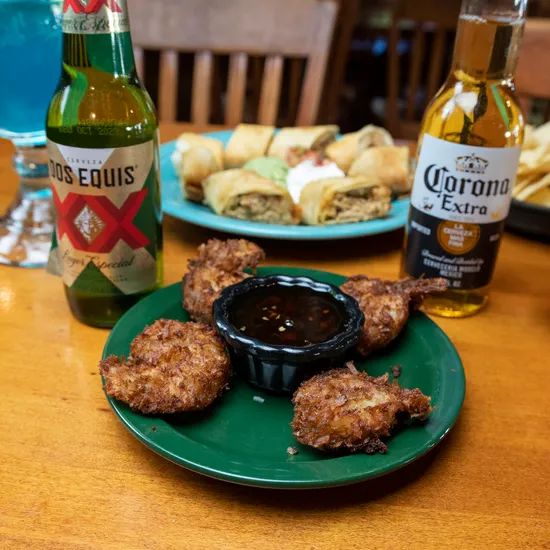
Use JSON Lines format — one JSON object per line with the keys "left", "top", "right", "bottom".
{"left": 453, "top": 0, "right": 526, "bottom": 81}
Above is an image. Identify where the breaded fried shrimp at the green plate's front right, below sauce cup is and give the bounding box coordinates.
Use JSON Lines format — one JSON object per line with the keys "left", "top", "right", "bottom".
{"left": 291, "top": 367, "right": 432, "bottom": 454}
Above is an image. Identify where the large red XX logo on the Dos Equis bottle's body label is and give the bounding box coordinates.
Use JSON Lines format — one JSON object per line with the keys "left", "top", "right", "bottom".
{"left": 52, "top": 188, "right": 149, "bottom": 253}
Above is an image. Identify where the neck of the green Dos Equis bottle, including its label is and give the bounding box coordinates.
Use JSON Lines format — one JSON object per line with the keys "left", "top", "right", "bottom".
{"left": 63, "top": 0, "right": 135, "bottom": 76}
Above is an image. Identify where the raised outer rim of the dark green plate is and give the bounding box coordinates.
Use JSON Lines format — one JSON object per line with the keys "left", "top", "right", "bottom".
{"left": 102, "top": 266, "right": 466, "bottom": 489}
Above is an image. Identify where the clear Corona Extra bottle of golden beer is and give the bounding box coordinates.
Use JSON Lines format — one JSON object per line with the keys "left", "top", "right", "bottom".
{"left": 402, "top": 0, "right": 526, "bottom": 317}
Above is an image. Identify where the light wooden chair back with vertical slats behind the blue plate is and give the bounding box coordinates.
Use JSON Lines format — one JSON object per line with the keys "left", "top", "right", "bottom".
{"left": 130, "top": 0, "right": 337, "bottom": 126}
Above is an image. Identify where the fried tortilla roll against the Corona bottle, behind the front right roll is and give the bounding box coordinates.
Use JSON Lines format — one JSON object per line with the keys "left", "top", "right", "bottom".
{"left": 348, "top": 147, "right": 411, "bottom": 193}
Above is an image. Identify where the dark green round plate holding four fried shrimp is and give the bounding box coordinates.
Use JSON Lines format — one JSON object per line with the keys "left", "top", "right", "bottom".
{"left": 103, "top": 267, "right": 465, "bottom": 488}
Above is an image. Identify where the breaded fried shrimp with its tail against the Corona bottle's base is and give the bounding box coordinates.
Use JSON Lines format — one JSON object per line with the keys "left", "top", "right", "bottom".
{"left": 341, "top": 275, "right": 447, "bottom": 356}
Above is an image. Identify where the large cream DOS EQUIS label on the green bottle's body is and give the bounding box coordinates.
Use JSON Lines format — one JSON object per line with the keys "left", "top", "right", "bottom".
{"left": 48, "top": 140, "right": 157, "bottom": 294}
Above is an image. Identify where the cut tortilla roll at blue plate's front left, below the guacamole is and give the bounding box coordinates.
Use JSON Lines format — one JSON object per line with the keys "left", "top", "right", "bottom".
{"left": 202, "top": 169, "right": 300, "bottom": 225}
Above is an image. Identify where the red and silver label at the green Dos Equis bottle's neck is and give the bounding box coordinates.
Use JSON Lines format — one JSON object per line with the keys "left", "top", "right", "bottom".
{"left": 63, "top": 0, "right": 130, "bottom": 34}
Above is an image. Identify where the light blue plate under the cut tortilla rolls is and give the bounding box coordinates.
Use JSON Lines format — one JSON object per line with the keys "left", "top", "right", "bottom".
{"left": 160, "top": 130, "right": 409, "bottom": 240}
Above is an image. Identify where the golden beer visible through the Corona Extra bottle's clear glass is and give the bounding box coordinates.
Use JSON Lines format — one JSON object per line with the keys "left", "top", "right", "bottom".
{"left": 401, "top": 14, "right": 524, "bottom": 317}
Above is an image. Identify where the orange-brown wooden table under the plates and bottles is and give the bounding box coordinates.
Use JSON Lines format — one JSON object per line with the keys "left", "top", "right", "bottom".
{"left": 0, "top": 125, "right": 550, "bottom": 550}
